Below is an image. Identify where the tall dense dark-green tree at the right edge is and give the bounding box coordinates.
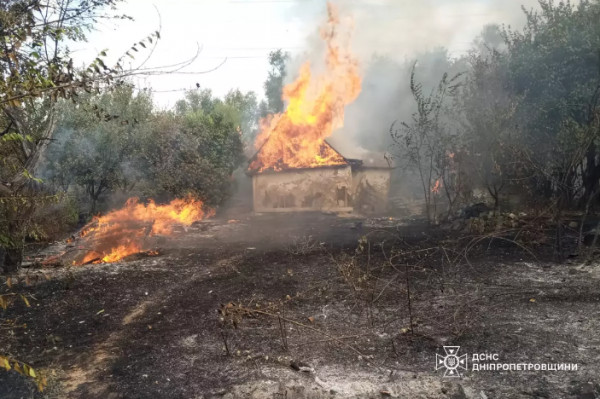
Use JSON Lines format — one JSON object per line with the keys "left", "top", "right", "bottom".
{"left": 505, "top": 0, "right": 600, "bottom": 206}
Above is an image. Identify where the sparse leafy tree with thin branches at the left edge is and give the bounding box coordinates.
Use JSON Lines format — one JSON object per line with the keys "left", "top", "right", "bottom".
{"left": 0, "top": 0, "right": 159, "bottom": 271}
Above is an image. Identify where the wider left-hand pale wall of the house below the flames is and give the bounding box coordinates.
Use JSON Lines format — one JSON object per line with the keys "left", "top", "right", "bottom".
{"left": 252, "top": 165, "right": 353, "bottom": 212}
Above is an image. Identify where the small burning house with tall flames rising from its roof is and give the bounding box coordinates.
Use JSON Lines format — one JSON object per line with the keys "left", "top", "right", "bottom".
{"left": 248, "top": 4, "right": 390, "bottom": 213}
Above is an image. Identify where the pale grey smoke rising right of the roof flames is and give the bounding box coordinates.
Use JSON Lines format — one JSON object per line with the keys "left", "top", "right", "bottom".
{"left": 287, "top": 0, "right": 538, "bottom": 159}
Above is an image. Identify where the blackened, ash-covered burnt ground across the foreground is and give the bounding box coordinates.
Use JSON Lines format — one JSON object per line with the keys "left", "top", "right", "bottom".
{"left": 0, "top": 214, "right": 600, "bottom": 399}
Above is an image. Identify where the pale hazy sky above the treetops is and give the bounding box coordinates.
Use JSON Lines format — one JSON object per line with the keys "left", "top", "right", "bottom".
{"left": 74, "top": 0, "right": 537, "bottom": 107}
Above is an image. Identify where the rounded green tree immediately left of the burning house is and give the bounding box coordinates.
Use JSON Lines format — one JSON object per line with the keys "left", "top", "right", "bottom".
{"left": 141, "top": 92, "right": 243, "bottom": 206}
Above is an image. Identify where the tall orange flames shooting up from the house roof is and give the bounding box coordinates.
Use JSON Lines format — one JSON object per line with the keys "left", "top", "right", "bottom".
{"left": 249, "top": 3, "right": 362, "bottom": 172}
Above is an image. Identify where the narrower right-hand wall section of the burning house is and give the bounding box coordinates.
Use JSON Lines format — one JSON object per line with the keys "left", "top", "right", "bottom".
{"left": 352, "top": 168, "right": 391, "bottom": 214}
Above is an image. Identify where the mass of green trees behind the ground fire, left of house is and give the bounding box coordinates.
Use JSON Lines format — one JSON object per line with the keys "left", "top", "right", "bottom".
{"left": 45, "top": 86, "right": 246, "bottom": 213}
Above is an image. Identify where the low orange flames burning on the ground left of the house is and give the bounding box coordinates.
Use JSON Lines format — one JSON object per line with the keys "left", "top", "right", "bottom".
{"left": 75, "top": 197, "right": 214, "bottom": 265}
